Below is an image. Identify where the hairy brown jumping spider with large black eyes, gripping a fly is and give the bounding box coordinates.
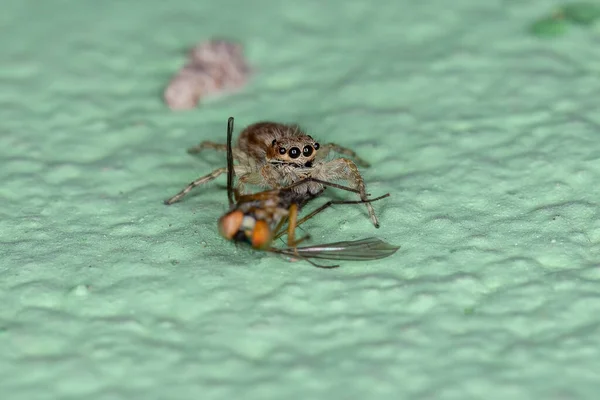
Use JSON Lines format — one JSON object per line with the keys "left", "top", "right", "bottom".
{"left": 165, "top": 118, "right": 379, "bottom": 228}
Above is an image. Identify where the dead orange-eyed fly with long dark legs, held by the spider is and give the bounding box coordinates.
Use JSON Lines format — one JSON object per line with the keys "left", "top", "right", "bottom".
{"left": 218, "top": 117, "right": 399, "bottom": 268}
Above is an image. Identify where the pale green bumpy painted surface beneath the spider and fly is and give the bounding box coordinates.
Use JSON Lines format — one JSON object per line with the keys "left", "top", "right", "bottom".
{"left": 0, "top": 0, "right": 600, "bottom": 400}
